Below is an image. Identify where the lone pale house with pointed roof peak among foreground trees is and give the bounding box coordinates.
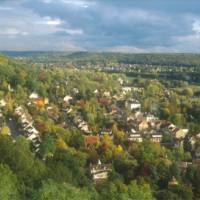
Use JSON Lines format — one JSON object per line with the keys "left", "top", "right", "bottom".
{"left": 90, "top": 160, "right": 111, "bottom": 183}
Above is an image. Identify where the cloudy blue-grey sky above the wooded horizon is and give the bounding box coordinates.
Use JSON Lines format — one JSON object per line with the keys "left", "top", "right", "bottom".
{"left": 0, "top": 0, "right": 200, "bottom": 53}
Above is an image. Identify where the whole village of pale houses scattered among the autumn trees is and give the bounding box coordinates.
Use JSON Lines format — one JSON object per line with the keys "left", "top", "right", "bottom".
{"left": 0, "top": 78, "right": 200, "bottom": 182}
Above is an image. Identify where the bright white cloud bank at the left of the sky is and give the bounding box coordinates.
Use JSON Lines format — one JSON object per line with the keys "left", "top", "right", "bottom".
{"left": 0, "top": 7, "right": 84, "bottom": 38}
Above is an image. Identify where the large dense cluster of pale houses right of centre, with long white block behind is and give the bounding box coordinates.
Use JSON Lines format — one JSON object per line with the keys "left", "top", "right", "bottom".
{"left": 99, "top": 85, "right": 189, "bottom": 146}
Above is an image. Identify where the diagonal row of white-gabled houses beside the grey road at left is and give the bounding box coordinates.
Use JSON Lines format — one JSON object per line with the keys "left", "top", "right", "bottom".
{"left": 14, "top": 106, "right": 41, "bottom": 152}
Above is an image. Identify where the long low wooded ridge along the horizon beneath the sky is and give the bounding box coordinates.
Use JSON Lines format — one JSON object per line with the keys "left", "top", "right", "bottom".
{"left": 1, "top": 51, "right": 200, "bottom": 67}
